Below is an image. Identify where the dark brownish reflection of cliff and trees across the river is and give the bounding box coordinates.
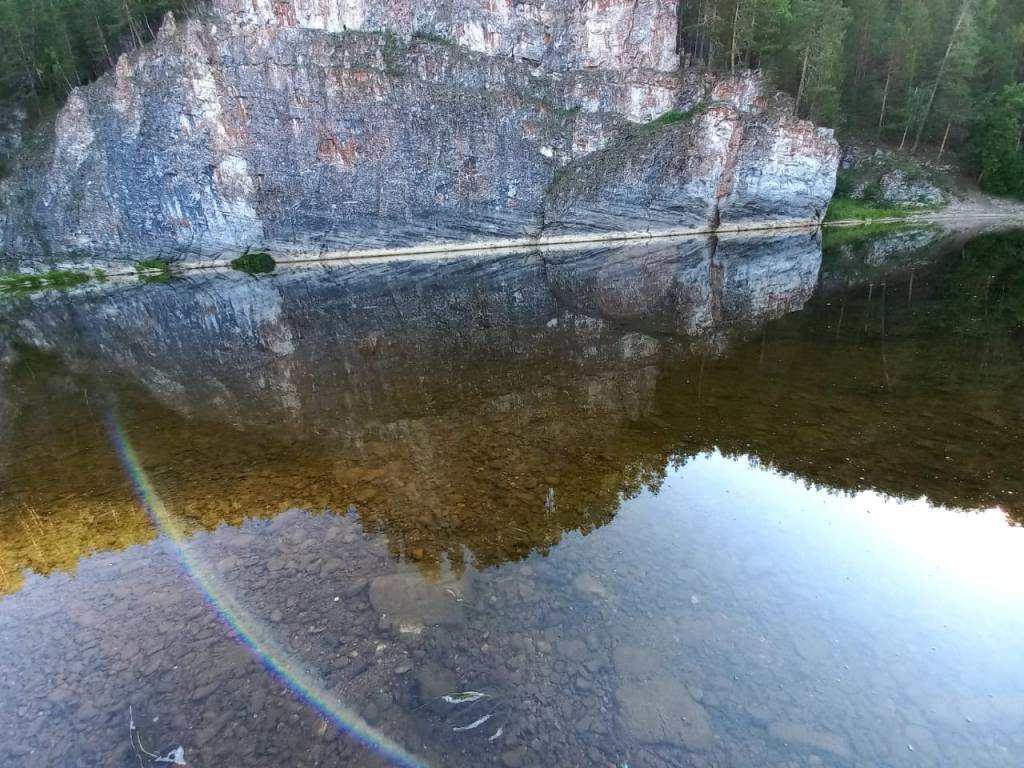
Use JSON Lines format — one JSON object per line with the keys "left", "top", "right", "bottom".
{"left": 0, "top": 228, "right": 1024, "bottom": 591}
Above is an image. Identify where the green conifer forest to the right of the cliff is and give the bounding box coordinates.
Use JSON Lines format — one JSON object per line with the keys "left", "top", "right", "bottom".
{"left": 680, "top": 0, "right": 1024, "bottom": 194}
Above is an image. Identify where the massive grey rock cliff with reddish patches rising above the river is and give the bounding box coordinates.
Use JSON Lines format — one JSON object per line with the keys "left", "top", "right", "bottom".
{"left": 0, "top": 0, "right": 839, "bottom": 264}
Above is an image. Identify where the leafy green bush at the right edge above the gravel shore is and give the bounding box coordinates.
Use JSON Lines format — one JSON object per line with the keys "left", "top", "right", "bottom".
{"left": 971, "top": 83, "right": 1024, "bottom": 197}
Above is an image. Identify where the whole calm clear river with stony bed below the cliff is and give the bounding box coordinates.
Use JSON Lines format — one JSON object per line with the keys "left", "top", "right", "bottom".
{"left": 0, "top": 232, "right": 1024, "bottom": 768}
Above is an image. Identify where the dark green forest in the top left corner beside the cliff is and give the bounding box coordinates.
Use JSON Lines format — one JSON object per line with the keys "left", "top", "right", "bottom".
{"left": 0, "top": 0, "right": 188, "bottom": 111}
